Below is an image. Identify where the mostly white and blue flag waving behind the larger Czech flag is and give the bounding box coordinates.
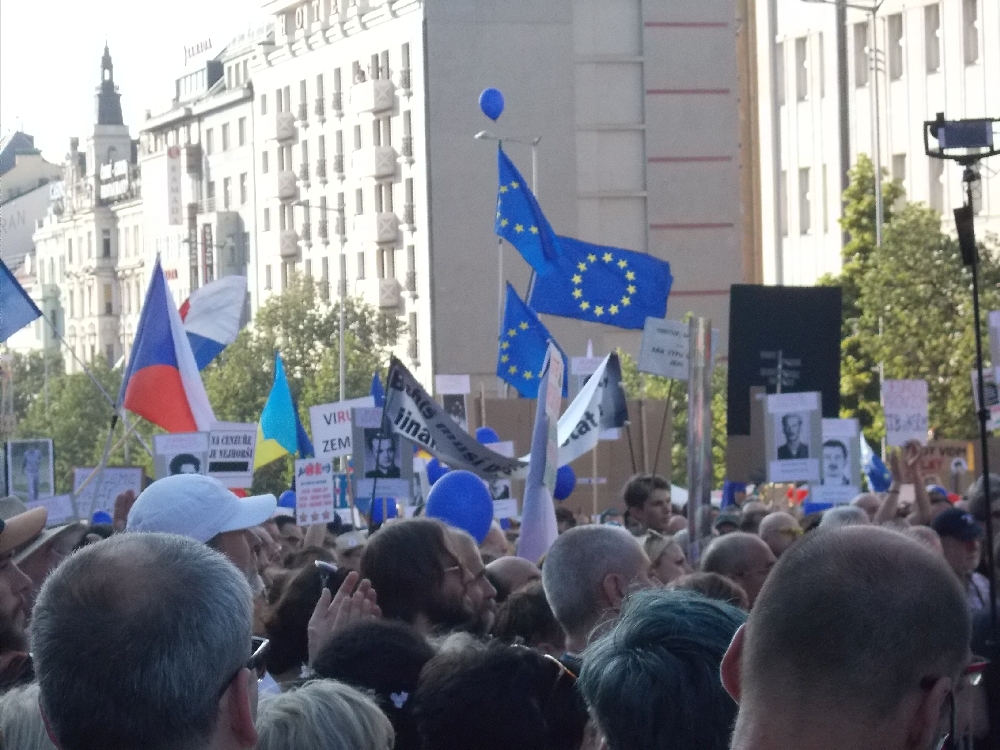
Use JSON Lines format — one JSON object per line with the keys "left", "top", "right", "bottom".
{"left": 180, "top": 276, "right": 247, "bottom": 370}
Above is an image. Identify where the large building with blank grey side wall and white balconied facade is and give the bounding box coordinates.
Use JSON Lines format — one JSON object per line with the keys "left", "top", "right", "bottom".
{"left": 250, "top": 0, "right": 760, "bottom": 390}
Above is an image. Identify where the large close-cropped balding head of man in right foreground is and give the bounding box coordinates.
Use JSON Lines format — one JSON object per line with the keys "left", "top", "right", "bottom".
{"left": 722, "top": 526, "right": 971, "bottom": 750}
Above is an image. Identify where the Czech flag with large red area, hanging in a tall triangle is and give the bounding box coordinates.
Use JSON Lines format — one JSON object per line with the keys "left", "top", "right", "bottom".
{"left": 118, "top": 258, "right": 215, "bottom": 432}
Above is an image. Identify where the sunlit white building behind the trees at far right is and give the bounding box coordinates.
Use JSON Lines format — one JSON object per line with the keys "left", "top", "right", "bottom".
{"left": 757, "top": 0, "right": 1000, "bottom": 285}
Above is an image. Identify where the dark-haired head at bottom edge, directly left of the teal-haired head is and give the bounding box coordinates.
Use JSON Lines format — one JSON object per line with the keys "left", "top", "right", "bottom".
{"left": 415, "top": 642, "right": 587, "bottom": 750}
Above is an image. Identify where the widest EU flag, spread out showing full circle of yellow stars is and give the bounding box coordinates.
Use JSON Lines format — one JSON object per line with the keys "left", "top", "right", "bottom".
{"left": 528, "top": 237, "right": 674, "bottom": 329}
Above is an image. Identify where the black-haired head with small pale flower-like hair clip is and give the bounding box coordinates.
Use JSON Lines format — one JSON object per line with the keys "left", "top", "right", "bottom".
{"left": 313, "top": 620, "right": 434, "bottom": 750}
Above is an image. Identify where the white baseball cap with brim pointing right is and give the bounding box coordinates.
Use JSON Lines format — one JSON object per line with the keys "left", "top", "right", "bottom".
{"left": 125, "top": 474, "right": 278, "bottom": 542}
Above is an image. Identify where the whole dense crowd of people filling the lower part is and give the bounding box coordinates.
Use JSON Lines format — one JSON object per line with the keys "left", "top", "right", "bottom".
{"left": 0, "top": 444, "right": 1000, "bottom": 750}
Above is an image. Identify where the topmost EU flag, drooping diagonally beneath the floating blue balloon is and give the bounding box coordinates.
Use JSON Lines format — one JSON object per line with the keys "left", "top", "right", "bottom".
{"left": 495, "top": 148, "right": 560, "bottom": 276}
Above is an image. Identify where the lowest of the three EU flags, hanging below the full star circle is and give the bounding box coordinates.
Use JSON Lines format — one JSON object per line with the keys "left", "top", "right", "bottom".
{"left": 497, "top": 284, "right": 569, "bottom": 398}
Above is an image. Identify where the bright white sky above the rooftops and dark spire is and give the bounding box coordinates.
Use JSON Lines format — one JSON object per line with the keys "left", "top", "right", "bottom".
{"left": 0, "top": 0, "right": 263, "bottom": 163}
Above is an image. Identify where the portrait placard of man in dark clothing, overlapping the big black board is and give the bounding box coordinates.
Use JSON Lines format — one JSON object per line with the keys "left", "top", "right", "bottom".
{"left": 765, "top": 392, "right": 823, "bottom": 482}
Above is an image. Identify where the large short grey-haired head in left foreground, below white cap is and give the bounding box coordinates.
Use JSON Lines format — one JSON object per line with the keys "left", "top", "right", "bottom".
{"left": 31, "top": 533, "right": 257, "bottom": 750}
